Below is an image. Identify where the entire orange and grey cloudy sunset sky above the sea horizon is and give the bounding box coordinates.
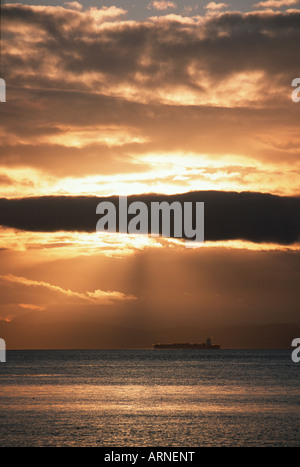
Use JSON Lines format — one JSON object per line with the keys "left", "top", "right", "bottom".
{"left": 0, "top": 0, "right": 300, "bottom": 348}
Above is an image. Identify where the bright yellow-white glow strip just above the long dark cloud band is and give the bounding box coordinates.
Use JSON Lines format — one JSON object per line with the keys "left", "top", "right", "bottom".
{"left": 0, "top": 153, "right": 300, "bottom": 198}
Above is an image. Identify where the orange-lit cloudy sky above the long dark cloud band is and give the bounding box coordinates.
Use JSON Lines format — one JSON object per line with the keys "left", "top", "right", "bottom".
{"left": 0, "top": 2, "right": 300, "bottom": 201}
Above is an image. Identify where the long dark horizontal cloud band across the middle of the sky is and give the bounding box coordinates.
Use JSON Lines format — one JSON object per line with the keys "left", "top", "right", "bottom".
{"left": 0, "top": 191, "right": 300, "bottom": 244}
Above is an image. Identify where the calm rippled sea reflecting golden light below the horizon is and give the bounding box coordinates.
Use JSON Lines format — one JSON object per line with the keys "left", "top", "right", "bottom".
{"left": 0, "top": 349, "right": 300, "bottom": 447}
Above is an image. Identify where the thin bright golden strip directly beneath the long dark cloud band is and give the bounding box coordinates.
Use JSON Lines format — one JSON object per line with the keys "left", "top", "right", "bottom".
{"left": 0, "top": 228, "right": 300, "bottom": 264}
